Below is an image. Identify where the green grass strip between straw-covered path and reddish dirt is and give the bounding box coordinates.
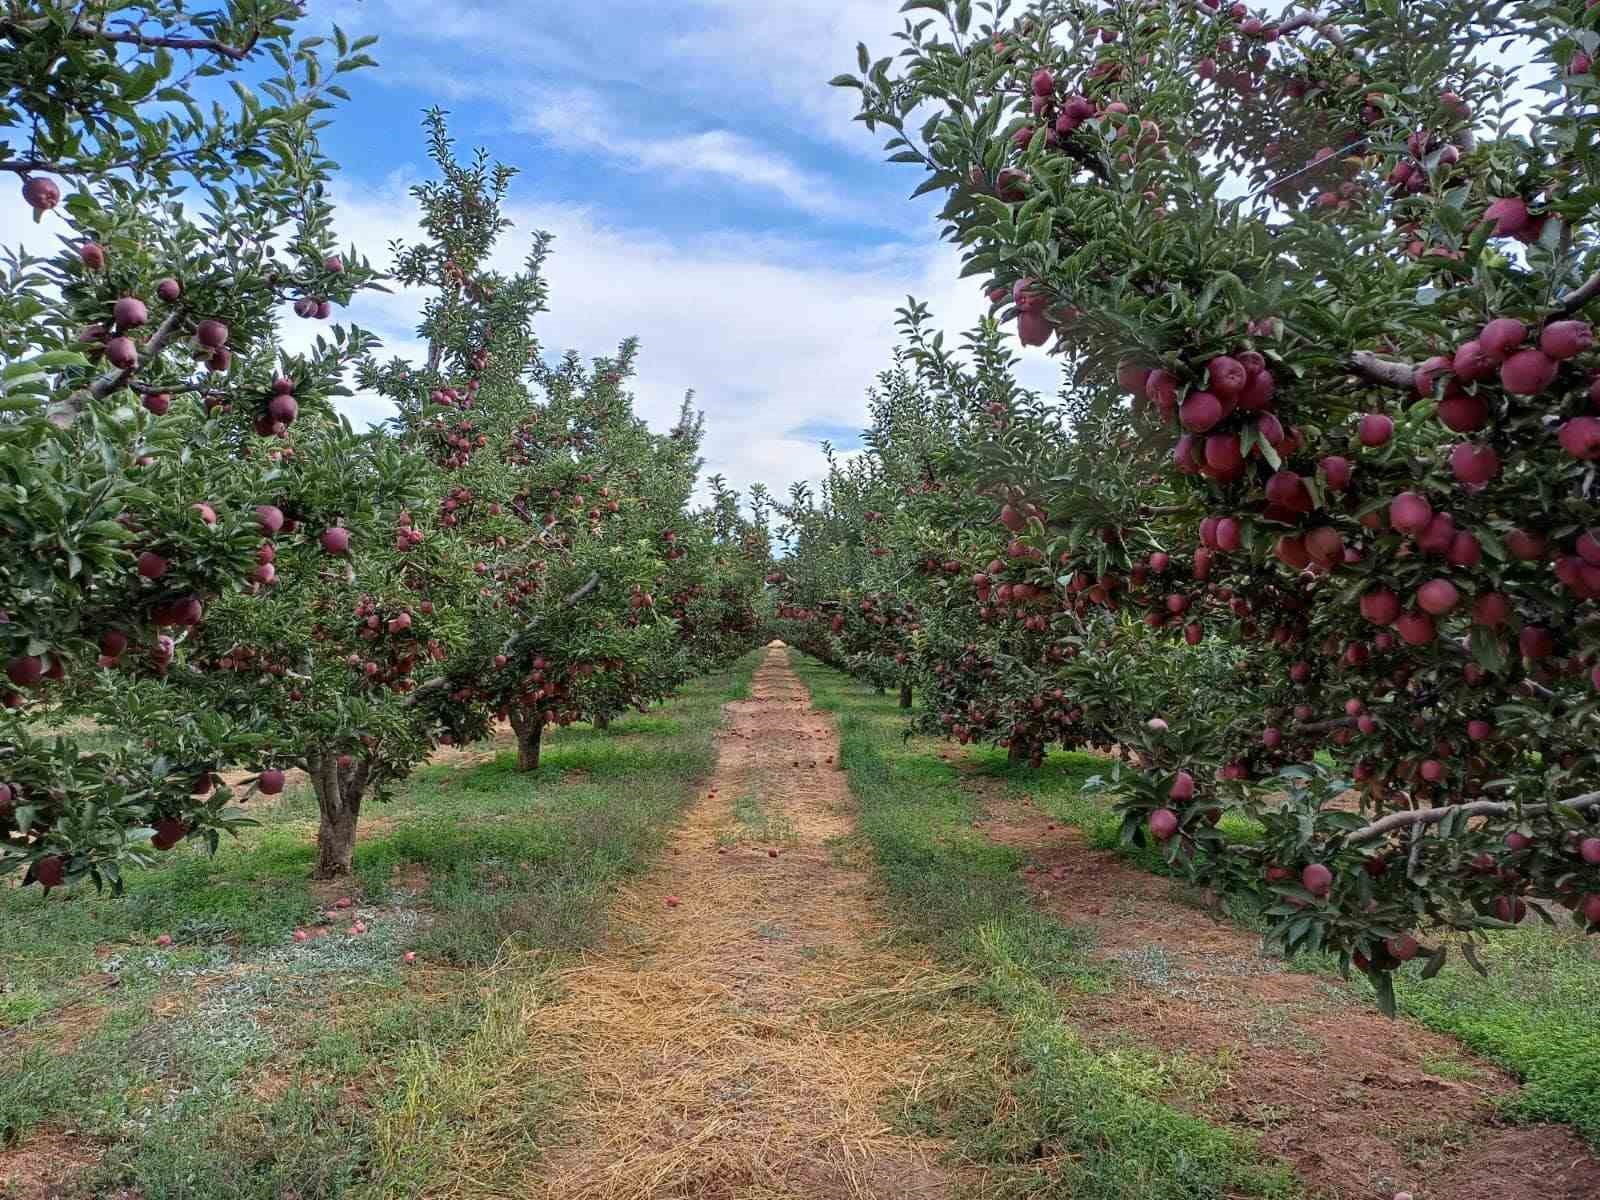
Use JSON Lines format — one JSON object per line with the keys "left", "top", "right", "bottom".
{"left": 790, "top": 654, "right": 1299, "bottom": 1200}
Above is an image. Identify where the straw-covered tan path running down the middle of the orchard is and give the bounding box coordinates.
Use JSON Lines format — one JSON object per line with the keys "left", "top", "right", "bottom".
{"left": 523, "top": 648, "right": 987, "bottom": 1200}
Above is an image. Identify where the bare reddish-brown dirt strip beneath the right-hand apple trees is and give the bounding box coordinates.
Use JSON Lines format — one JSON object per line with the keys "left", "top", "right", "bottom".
{"left": 971, "top": 779, "right": 1600, "bottom": 1200}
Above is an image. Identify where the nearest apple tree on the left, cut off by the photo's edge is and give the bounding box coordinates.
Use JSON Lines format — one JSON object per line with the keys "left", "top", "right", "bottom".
{"left": 0, "top": 0, "right": 382, "bottom": 890}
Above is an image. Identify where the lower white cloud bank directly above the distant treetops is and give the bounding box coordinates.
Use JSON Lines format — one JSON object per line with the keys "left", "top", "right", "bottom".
{"left": 318, "top": 172, "right": 1056, "bottom": 502}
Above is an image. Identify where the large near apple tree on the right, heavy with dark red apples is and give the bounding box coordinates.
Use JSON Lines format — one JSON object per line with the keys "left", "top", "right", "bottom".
{"left": 835, "top": 0, "right": 1600, "bottom": 1005}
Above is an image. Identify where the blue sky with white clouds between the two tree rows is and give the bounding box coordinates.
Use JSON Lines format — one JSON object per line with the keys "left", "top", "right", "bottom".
{"left": 290, "top": 0, "right": 1054, "bottom": 490}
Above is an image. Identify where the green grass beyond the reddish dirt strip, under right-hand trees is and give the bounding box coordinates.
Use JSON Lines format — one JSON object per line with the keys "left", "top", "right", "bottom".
{"left": 947, "top": 704, "right": 1600, "bottom": 1147}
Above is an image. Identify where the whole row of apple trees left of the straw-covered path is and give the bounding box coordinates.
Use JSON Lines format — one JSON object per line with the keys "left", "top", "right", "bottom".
{"left": 0, "top": 11, "right": 768, "bottom": 891}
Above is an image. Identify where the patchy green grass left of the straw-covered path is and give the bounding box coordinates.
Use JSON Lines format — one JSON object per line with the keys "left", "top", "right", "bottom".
{"left": 0, "top": 656, "right": 757, "bottom": 1200}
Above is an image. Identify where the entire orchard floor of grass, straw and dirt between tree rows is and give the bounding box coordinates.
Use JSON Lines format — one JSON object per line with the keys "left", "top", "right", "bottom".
{"left": 12, "top": 659, "right": 1600, "bottom": 1200}
